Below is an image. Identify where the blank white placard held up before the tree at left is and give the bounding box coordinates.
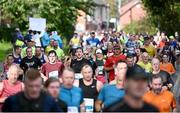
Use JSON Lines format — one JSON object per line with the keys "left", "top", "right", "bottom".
{"left": 29, "top": 18, "right": 46, "bottom": 31}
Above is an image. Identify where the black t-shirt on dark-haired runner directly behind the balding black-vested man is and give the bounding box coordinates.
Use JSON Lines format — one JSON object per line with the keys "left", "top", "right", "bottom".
{"left": 70, "top": 58, "right": 93, "bottom": 73}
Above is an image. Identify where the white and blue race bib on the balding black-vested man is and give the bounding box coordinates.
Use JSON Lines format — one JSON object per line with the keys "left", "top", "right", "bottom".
{"left": 84, "top": 98, "right": 94, "bottom": 112}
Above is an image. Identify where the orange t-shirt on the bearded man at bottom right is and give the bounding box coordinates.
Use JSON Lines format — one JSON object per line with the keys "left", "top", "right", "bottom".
{"left": 143, "top": 90, "right": 176, "bottom": 112}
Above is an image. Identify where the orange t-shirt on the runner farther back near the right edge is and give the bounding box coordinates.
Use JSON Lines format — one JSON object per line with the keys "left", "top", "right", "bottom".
{"left": 160, "top": 63, "right": 176, "bottom": 75}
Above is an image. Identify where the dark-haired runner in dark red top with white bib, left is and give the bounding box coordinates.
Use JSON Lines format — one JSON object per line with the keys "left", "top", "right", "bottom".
{"left": 41, "top": 50, "right": 64, "bottom": 81}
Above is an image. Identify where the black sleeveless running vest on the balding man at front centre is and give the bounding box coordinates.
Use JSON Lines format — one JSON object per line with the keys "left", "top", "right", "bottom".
{"left": 79, "top": 79, "right": 98, "bottom": 101}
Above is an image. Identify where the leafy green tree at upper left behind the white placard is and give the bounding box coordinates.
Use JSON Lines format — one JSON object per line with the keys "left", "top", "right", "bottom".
{"left": 0, "top": 0, "right": 94, "bottom": 38}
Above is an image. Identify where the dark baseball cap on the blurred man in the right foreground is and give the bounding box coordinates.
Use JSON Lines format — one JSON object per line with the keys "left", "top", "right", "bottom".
{"left": 126, "top": 65, "right": 148, "bottom": 80}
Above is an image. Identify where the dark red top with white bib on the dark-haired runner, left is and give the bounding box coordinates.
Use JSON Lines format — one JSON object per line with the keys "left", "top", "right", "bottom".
{"left": 41, "top": 62, "right": 64, "bottom": 78}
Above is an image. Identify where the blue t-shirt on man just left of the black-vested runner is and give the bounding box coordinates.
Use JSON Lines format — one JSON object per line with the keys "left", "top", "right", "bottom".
{"left": 59, "top": 86, "right": 83, "bottom": 108}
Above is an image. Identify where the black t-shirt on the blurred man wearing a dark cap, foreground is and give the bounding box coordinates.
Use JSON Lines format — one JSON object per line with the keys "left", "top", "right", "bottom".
{"left": 103, "top": 99, "right": 159, "bottom": 112}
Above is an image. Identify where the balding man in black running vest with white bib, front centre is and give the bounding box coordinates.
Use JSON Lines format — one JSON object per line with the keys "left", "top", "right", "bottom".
{"left": 74, "top": 65, "right": 103, "bottom": 112}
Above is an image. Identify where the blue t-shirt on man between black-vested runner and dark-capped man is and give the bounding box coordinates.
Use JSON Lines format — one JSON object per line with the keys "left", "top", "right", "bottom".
{"left": 98, "top": 85, "right": 125, "bottom": 107}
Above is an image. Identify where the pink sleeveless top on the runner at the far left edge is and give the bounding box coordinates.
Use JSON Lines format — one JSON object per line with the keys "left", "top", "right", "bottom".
{"left": 0, "top": 80, "right": 22, "bottom": 97}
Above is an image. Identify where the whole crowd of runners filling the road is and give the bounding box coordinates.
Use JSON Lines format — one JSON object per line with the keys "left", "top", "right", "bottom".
{"left": 0, "top": 28, "right": 180, "bottom": 112}
